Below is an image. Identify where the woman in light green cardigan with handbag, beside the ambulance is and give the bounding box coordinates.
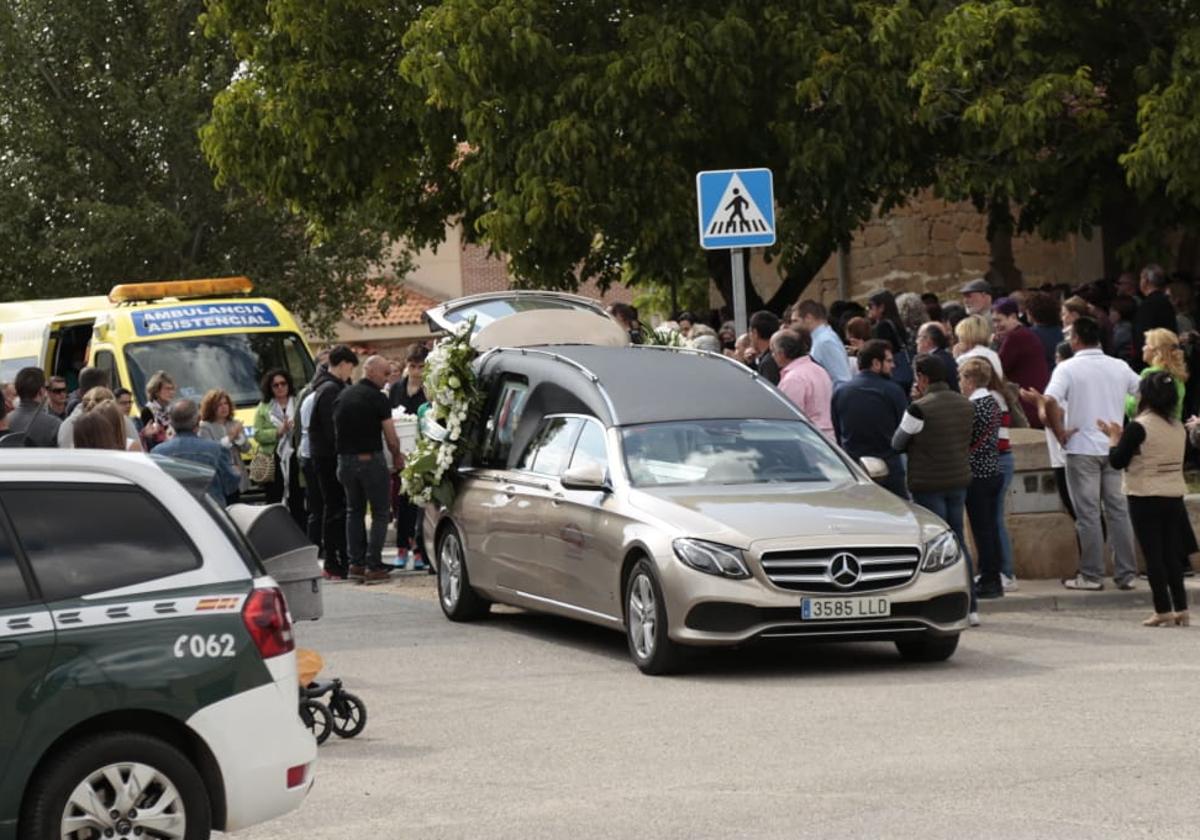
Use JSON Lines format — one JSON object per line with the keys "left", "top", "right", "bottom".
{"left": 251, "top": 367, "right": 308, "bottom": 533}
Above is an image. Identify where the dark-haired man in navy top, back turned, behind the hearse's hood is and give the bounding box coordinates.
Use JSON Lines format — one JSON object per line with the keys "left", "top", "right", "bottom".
{"left": 833, "top": 338, "right": 908, "bottom": 499}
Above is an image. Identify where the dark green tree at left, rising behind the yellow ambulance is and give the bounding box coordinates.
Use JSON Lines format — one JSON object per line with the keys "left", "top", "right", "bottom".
{"left": 0, "top": 0, "right": 396, "bottom": 331}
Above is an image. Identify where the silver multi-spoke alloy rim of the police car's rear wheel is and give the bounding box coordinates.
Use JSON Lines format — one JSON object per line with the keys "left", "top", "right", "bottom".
{"left": 59, "top": 762, "right": 187, "bottom": 840}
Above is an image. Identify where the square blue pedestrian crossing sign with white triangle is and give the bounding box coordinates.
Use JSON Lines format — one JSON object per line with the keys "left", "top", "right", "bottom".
{"left": 696, "top": 169, "right": 775, "bottom": 250}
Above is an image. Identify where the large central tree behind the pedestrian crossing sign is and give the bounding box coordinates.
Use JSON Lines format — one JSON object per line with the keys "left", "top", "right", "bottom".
{"left": 204, "top": 0, "right": 932, "bottom": 310}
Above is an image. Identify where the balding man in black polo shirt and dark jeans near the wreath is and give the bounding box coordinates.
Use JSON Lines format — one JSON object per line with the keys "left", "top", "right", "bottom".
{"left": 334, "top": 356, "right": 403, "bottom": 583}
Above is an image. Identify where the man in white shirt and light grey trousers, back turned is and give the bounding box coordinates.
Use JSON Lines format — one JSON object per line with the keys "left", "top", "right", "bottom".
{"left": 1021, "top": 318, "right": 1140, "bottom": 590}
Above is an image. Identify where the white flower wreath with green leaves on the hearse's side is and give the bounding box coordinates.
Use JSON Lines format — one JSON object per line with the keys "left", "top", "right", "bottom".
{"left": 401, "top": 319, "right": 480, "bottom": 505}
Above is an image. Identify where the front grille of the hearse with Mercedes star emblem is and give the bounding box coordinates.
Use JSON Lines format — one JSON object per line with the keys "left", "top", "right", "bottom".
{"left": 760, "top": 547, "right": 920, "bottom": 595}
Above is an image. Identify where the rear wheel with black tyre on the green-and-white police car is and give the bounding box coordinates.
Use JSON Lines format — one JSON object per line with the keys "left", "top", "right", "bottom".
{"left": 20, "top": 732, "right": 212, "bottom": 840}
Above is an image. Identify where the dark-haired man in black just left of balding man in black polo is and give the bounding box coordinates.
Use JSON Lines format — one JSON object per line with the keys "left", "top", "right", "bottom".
{"left": 308, "top": 344, "right": 359, "bottom": 580}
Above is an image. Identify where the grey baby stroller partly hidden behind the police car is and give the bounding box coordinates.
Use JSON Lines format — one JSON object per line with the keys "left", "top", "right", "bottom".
{"left": 227, "top": 504, "right": 367, "bottom": 744}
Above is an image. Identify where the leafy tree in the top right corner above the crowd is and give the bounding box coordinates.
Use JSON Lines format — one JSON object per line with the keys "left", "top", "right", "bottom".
{"left": 875, "top": 0, "right": 1200, "bottom": 272}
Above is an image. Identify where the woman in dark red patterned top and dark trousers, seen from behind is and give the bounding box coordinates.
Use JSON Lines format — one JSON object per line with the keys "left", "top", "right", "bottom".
{"left": 959, "top": 359, "right": 1004, "bottom": 598}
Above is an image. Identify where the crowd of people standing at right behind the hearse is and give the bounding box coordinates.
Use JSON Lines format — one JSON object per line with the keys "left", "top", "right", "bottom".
{"left": 628, "top": 265, "right": 1200, "bottom": 626}
